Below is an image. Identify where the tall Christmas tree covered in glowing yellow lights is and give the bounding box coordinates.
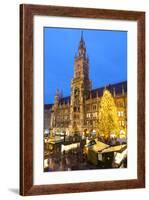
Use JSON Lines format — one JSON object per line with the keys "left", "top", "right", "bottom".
{"left": 98, "top": 89, "right": 120, "bottom": 139}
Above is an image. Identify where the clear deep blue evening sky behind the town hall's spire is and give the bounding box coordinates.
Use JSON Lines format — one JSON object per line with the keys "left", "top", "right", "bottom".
{"left": 44, "top": 27, "right": 127, "bottom": 104}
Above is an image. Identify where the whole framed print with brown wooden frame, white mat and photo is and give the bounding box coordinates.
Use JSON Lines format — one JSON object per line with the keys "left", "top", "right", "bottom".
{"left": 20, "top": 4, "right": 145, "bottom": 195}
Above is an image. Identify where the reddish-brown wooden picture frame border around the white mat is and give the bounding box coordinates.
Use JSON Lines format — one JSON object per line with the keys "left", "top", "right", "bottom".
{"left": 20, "top": 4, "right": 145, "bottom": 196}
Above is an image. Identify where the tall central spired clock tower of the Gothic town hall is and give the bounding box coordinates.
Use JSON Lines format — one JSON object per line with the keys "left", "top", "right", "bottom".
{"left": 70, "top": 32, "right": 92, "bottom": 134}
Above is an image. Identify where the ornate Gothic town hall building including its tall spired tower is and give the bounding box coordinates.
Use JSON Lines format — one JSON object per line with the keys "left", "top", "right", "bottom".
{"left": 44, "top": 35, "right": 127, "bottom": 134}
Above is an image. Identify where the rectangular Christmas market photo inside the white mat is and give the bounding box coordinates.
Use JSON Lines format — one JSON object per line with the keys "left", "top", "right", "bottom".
{"left": 43, "top": 27, "right": 129, "bottom": 173}
